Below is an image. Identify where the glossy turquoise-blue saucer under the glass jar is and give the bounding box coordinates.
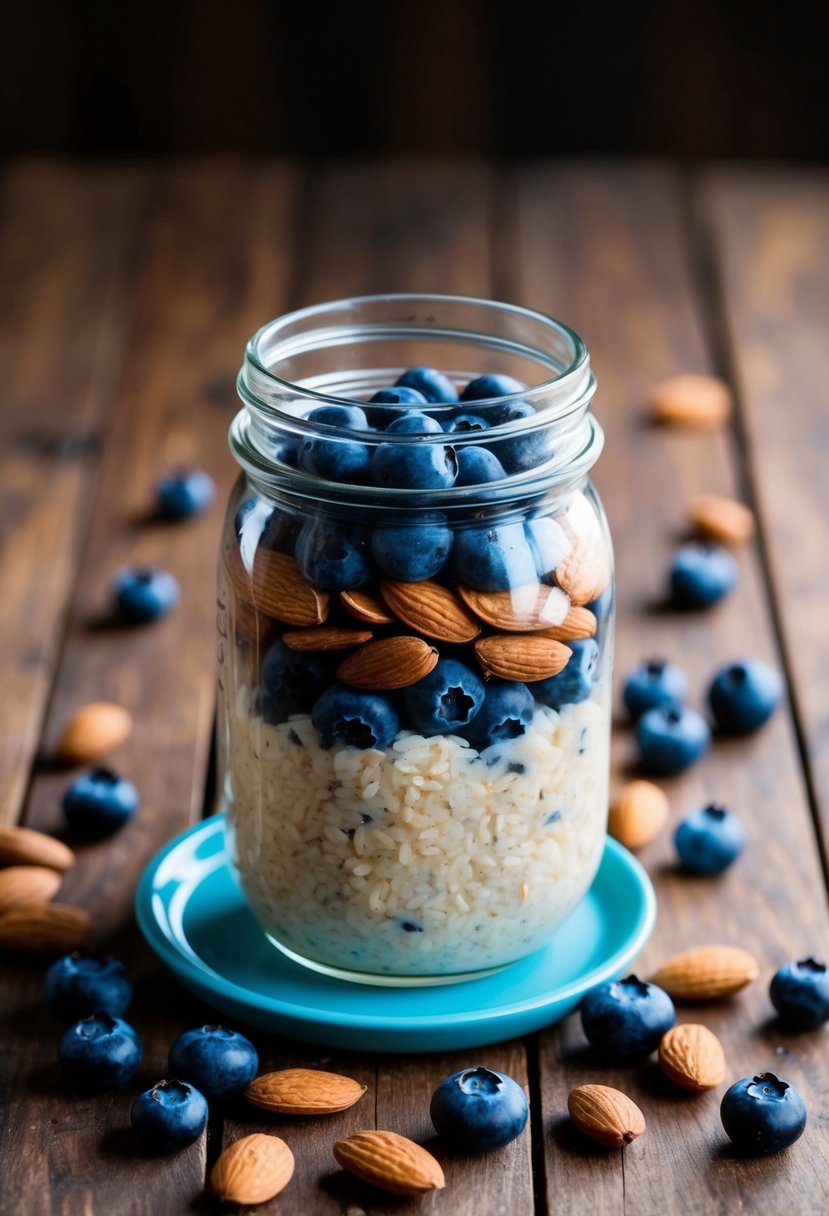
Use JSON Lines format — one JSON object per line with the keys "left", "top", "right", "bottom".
{"left": 135, "top": 815, "right": 656, "bottom": 1052}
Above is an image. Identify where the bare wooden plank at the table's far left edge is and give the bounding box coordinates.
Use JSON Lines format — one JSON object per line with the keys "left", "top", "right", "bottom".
{"left": 0, "top": 162, "right": 143, "bottom": 823}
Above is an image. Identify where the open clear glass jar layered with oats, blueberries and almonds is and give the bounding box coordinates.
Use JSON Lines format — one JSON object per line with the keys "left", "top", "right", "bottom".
{"left": 219, "top": 295, "right": 614, "bottom": 984}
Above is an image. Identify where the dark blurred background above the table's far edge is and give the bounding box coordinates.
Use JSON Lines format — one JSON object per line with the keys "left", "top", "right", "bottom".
{"left": 0, "top": 0, "right": 829, "bottom": 161}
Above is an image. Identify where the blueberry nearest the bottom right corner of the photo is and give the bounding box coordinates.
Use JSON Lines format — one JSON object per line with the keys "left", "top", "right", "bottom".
{"left": 720, "top": 1073, "right": 806, "bottom": 1154}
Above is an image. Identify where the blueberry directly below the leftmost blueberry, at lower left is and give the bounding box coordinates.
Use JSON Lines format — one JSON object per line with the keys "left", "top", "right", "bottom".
{"left": 57, "top": 1013, "right": 142, "bottom": 1093}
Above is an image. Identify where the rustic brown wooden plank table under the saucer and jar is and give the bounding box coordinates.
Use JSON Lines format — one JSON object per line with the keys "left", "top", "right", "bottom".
{"left": 0, "top": 162, "right": 829, "bottom": 1216}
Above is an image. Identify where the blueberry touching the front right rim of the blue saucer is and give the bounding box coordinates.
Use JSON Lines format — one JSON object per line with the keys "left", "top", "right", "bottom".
{"left": 581, "top": 975, "right": 676, "bottom": 1064}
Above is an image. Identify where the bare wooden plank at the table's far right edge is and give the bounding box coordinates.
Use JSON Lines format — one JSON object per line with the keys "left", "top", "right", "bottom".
{"left": 700, "top": 169, "right": 829, "bottom": 849}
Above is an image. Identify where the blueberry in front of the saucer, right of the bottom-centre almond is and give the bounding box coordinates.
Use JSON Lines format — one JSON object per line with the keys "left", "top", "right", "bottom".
{"left": 429, "top": 1068, "right": 530, "bottom": 1153}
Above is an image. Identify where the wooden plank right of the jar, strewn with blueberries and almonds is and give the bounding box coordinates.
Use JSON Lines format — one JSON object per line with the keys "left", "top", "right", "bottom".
{"left": 510, "top": 165, "right": 829, "bottom": 1216}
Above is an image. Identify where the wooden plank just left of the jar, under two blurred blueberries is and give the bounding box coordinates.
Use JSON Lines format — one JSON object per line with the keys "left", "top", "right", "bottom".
{"left": 0, "top": 162, "right": 294, "bottom": 1216}
